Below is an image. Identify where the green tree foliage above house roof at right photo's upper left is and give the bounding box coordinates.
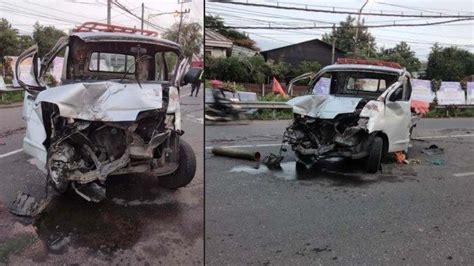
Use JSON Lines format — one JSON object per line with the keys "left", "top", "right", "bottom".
{"left": 204, "top": 16, "right": 260, "bottom": 51}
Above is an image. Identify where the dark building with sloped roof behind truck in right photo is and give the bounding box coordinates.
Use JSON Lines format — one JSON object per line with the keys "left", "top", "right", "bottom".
{"left": 262, "top": 42, "right": 345, "bottom": 67}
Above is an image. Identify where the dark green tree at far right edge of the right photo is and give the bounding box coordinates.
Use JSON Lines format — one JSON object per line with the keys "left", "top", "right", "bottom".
{"left": 424, "top": 43, "right": 474, "bottom": 81}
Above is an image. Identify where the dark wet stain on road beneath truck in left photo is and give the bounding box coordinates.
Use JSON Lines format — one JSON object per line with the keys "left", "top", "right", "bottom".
{"left": 35, "top": 176, "right": 181, "bottom": 254}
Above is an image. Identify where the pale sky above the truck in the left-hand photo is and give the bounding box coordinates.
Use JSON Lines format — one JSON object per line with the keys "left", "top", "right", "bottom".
{"left": 0, "top": 0, "right": 204, "bottom": 34}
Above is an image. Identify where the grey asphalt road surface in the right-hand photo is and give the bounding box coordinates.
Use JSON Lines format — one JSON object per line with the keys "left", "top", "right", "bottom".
{"left": 205, "top": 119, "right": 474, "bottom": 265}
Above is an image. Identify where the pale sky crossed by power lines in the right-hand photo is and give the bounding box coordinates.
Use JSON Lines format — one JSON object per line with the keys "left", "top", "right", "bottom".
{"left": 205, "top": 0, "right": 474, "bottom": 60}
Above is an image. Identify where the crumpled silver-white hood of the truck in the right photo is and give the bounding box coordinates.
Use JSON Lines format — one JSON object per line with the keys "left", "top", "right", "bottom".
{"left": 287, "top": 95, "right": 362, "bottom": 119}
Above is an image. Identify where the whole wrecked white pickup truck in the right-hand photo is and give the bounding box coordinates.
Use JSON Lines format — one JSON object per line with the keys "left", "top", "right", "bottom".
{"left": 284, "top": 60, "right": 415, "bottom": 173}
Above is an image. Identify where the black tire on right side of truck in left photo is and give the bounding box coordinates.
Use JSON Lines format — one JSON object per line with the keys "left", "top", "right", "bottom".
{"left": 159, "top": 140, "right": 196, "bottom": 189}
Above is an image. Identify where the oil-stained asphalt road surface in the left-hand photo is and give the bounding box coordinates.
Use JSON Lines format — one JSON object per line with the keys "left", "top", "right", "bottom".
{"left": 0, "top": 88, "right": 204, "bottom": 265}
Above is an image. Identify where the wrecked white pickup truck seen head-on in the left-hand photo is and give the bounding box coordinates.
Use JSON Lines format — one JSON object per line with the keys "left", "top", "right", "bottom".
{"left": 16, "top": 23, "right": 198, "bottom": 202}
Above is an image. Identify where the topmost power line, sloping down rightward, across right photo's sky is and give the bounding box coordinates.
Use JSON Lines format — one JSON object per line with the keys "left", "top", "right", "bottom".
{"left": 215, "top": 1, "right": 474, "bottom": 18}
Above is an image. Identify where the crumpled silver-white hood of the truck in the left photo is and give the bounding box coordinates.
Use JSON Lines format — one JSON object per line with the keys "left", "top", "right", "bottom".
{"left": 35, "top": 81, "right": 163, "bottom": 121}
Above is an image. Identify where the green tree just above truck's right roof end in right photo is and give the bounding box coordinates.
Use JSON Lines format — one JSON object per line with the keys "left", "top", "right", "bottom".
{"left": 377, "top": 42, "right": 421, "bottom": 73}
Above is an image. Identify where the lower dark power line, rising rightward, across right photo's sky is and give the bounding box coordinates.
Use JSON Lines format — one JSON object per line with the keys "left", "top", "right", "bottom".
{"left": 214, "top": 18, "right": 474, "bottom": 30}
